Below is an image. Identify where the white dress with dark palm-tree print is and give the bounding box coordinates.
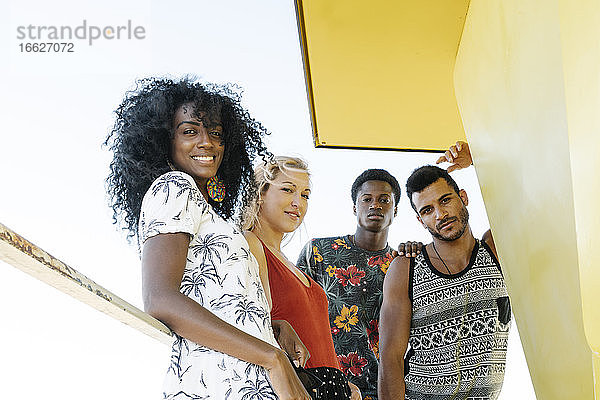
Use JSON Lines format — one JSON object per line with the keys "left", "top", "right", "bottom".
{"left": 140, "top": 171, "right": 277, "bottom": 400}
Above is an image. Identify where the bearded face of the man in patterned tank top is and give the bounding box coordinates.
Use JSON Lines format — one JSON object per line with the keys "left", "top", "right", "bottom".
{"left": 412, "top": 178, "right": 469, "bottom": 242}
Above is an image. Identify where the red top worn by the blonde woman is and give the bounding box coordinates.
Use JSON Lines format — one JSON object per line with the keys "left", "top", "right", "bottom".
{"left": 263, "top": 243, "right": 340, "bottom": 369}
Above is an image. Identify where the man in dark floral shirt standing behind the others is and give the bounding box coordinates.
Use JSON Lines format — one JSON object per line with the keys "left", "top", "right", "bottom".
{"left": 297, "top": 169, "right": 400, "bottom": 400}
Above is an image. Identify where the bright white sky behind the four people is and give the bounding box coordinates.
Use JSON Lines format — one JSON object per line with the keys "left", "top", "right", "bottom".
{"left": 0, "top": 0, "right": 535, "bottom": 399}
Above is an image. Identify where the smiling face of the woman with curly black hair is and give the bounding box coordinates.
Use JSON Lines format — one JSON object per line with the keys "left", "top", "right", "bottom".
{"left": 171, "top": 104, "right": 225, "bottom": 191}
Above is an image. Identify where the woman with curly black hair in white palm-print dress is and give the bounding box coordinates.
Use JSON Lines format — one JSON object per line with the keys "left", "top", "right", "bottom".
{"left": 105, "top": 79, "right": 309, "bottom": 400}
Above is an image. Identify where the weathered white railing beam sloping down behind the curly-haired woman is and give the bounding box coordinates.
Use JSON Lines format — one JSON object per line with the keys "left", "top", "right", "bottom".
{"left": 0, "top": 224, "right": 172, "bottom": 345}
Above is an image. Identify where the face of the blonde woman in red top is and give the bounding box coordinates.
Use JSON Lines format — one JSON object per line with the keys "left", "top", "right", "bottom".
{"left": 258, "top": 170, "right": 310, "bottom": 233}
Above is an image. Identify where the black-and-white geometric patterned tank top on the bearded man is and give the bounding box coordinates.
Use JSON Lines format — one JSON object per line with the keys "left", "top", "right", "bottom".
{"left": 405, "top": 241, "right": 510, "bottom": 400}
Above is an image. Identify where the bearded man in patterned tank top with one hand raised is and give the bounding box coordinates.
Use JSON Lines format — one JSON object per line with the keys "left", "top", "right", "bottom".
{"left": 379, "top": 142, "right": 510, "bottom": 400}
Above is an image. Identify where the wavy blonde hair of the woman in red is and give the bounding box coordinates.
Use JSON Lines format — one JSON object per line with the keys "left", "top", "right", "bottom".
{"left": 242, "top": 156, "right": 310, "bottom": 230}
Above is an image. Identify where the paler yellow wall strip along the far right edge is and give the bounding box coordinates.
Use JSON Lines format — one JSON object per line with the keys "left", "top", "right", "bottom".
{"left": 559, "top": 0, "right": 600, "bottom": 398}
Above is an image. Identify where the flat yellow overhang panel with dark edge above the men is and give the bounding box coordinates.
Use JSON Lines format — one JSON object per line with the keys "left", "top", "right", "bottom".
{"left": 296, "top": 0, "right": 469, "bottom": 150}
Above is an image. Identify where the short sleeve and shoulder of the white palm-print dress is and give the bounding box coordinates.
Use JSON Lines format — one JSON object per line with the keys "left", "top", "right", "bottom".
{"left": 139, "top": 171, "right": 210, "bottom": 244}
